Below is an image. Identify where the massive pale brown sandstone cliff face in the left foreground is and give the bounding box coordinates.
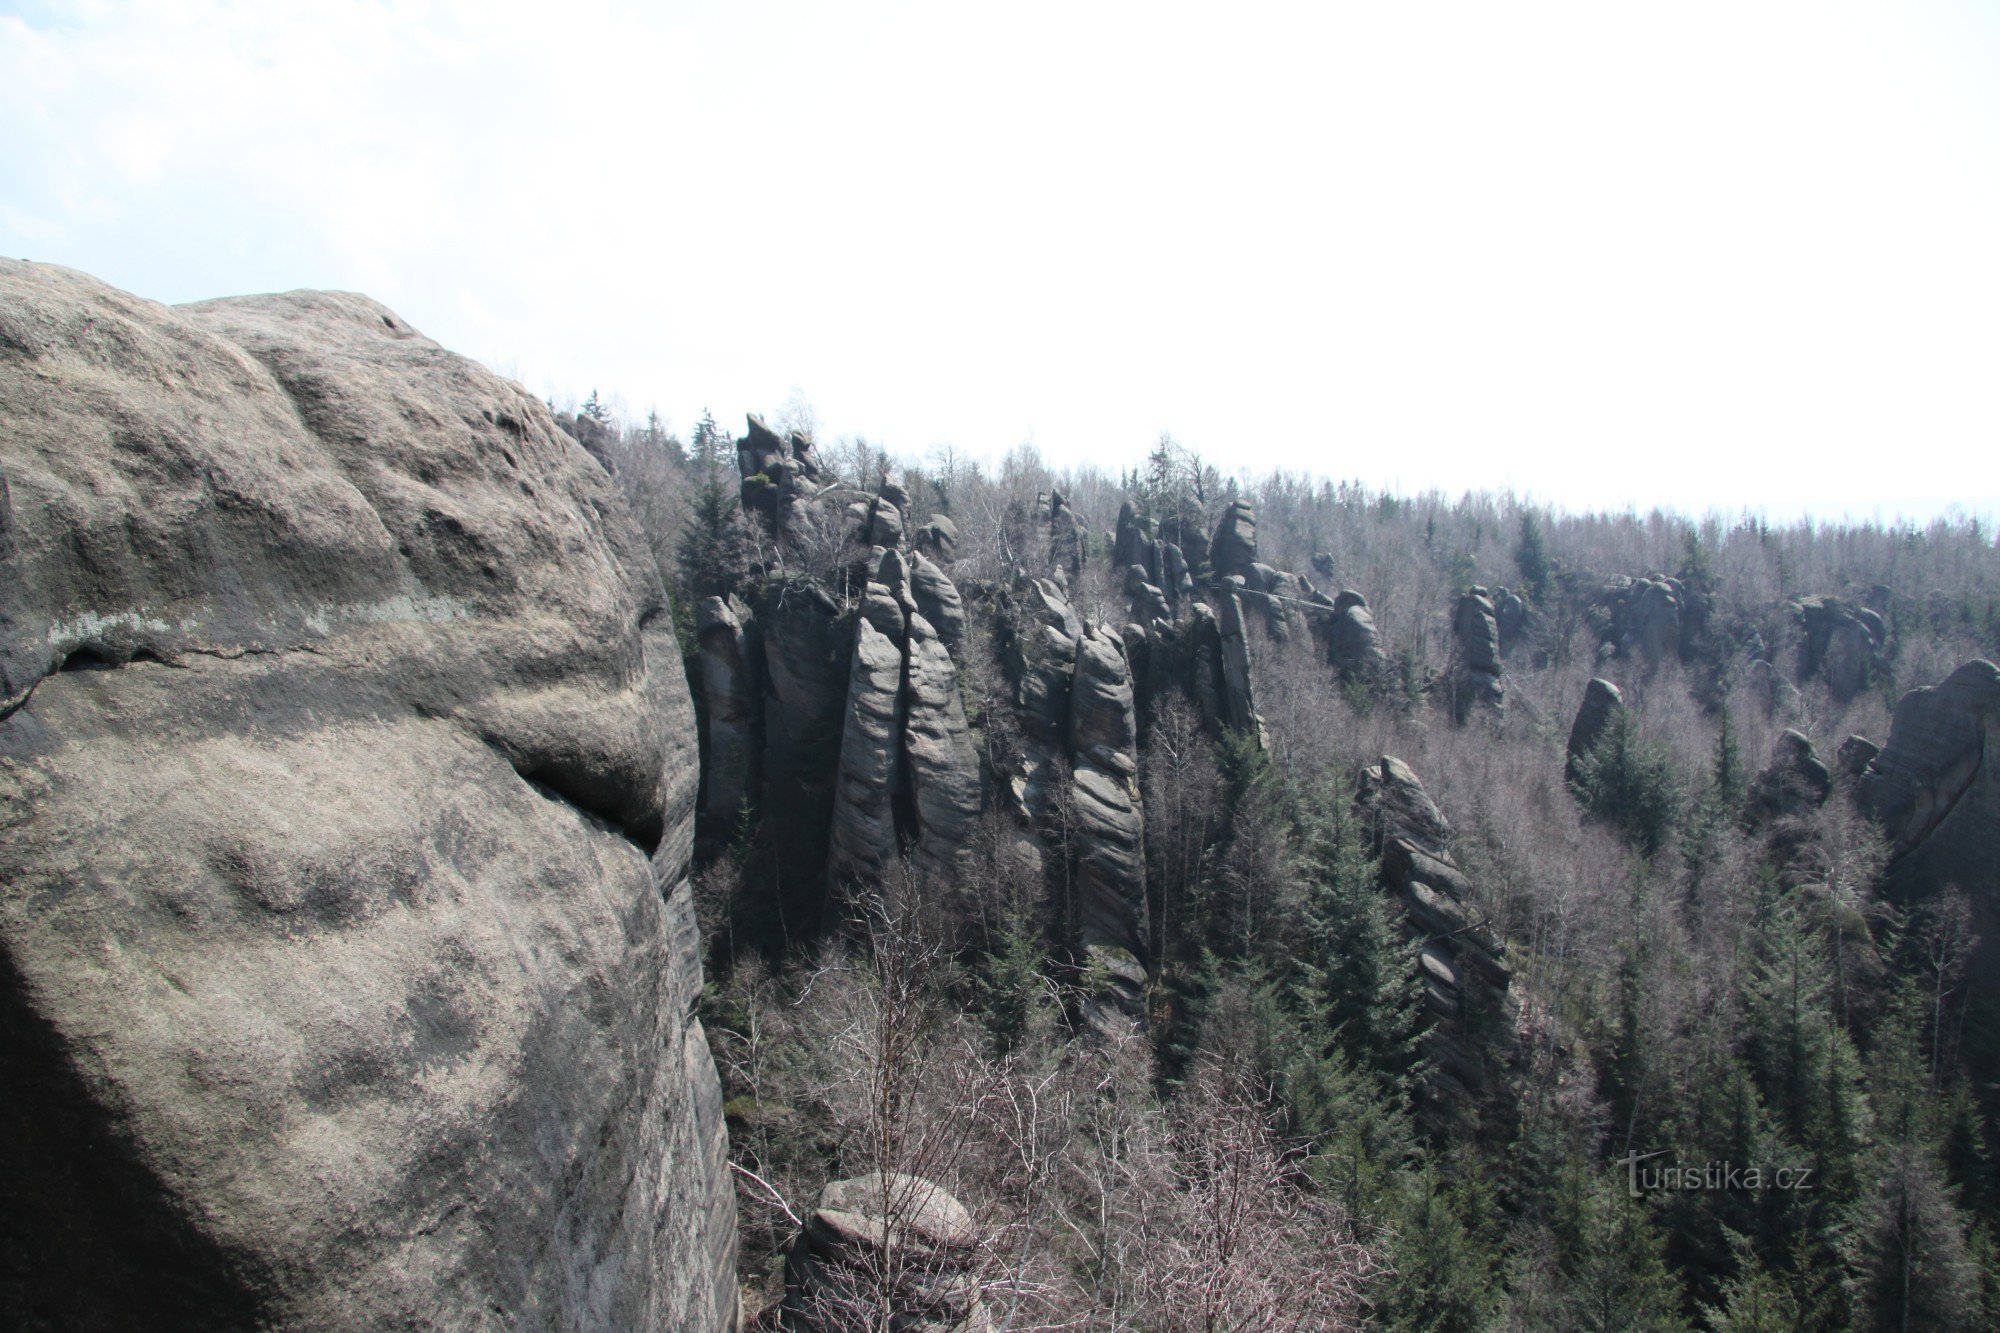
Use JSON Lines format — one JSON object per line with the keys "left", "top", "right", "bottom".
{"left": 0, "top": 262, "right": 734, "bottom": 1329}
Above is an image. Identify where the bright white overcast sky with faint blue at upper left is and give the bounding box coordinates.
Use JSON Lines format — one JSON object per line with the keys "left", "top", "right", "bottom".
{"left": 0, "top": 0, "right": 2000, "bottom": 518}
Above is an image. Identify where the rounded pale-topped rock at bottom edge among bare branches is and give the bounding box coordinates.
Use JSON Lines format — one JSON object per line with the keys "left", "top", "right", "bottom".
{"left": 784, "top": 1171, "right": 992, "bottom": 1333}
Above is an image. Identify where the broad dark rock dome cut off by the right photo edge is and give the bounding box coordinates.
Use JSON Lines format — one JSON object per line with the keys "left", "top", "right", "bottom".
{"left": 1856, "top": 658, "right": 2000, "bottom": 880}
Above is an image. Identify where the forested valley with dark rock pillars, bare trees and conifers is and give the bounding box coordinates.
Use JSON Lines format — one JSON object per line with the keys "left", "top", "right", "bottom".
{"left": 560, "top": 394, "right": 2000, "bottom": 1333}
